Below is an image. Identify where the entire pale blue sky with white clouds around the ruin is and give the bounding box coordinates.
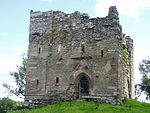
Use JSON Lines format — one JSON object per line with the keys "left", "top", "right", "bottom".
{"left": 0, "top": 0, "right": 150, "bottom": 102}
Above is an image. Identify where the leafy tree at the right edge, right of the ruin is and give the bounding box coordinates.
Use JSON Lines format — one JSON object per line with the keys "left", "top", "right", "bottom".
{"left": 135, "top": 58, "right": 150, "bottom": 100}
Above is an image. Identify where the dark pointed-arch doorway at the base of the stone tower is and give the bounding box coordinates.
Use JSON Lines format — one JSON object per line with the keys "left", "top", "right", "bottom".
{"left": 77, "top": 73, "right": 90, "bottom": 98}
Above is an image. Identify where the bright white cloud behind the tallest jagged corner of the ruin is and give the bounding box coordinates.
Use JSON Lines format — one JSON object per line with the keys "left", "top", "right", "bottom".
{"left": 95, "top": 0, "right": 150, "bottom": 21}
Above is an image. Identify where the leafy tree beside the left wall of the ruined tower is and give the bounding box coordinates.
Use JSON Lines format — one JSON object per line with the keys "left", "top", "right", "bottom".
{"left": 3, "top": 54, "right": 27, "bottom": 98}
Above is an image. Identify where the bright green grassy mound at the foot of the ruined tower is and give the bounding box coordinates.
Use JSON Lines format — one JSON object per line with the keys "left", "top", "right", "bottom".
{"left": 9, "top": 100, "right": 150, "bottom": 113}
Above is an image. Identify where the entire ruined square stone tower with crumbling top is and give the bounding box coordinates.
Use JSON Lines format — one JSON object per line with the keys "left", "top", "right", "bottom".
{"left": 25, "top": 6, "right": 134, "bottom": 106}
